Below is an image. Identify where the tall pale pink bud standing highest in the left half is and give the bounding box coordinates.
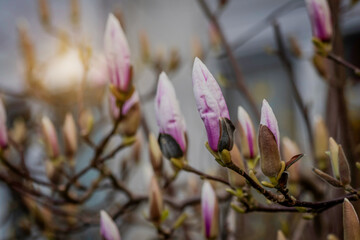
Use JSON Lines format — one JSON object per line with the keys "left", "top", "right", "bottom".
{"left": 104, "top": 14, "right": 131, "bottom": 92}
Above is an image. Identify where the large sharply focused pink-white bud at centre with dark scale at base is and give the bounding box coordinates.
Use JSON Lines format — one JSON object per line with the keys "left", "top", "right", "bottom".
{"left": 192, "top": 58, "right": 235, "bottom": 152}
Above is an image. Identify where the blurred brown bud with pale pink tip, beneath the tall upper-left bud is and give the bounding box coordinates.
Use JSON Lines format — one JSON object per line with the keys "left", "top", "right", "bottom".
{"left": 119, "top": 91, "right": 141, "bottom": 137}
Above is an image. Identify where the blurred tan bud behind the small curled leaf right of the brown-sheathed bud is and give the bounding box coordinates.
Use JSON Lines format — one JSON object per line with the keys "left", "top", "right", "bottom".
{"left": 282, "top": 137, "right": 301, "bottom": 183}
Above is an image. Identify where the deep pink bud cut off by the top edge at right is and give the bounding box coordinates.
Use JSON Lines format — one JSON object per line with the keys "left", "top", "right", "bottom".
{"left": 306, "top": 0, "right": 332, "bottom": 41}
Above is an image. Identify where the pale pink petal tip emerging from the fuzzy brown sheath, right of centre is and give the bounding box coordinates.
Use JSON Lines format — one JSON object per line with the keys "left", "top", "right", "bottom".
{"left": 260, "top": 99, "right": 280, "bottom": 149}
